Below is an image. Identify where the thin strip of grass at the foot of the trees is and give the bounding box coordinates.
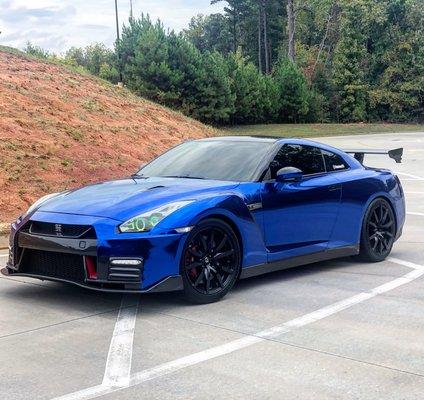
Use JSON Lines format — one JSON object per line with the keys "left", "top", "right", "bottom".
{"left": 221, "top": 123, "right": 424, "bottom": 137}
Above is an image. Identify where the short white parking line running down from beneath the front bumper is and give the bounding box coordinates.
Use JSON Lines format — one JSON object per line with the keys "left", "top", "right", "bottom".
{"left": 102, "top": 295, "right": 139, "bottom": 387}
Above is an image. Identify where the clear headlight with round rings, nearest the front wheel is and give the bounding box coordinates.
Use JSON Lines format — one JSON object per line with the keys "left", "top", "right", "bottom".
{"left": 119, "top": 200, "right": 193, "bottom": 233}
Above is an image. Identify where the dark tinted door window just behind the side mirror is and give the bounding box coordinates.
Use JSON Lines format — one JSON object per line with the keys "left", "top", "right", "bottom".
{"left": 270, "top": 144, "right": 325, "bottom": 179}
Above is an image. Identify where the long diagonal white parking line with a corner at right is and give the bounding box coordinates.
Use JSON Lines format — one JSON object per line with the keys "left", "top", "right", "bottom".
{"left": 53, "top": 258, "right": 424, "bottom": 400}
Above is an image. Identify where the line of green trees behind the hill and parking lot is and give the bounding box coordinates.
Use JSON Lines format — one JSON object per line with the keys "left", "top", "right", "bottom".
{"left": 24, "top": 0, "right": 424, "bottom": 124}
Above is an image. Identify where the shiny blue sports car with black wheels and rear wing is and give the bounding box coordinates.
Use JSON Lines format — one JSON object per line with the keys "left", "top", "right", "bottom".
{"left": 2, "top": 137, "right": 405, "bottom": 303}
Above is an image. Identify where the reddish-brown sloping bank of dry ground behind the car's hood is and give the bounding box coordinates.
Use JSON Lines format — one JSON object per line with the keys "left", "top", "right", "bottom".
{"left": 0, "top": 48, "right": 214, "bottom": 222}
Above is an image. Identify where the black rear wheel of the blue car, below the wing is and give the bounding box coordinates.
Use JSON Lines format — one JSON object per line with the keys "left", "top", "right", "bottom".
{"left": 360, "top": 199, "right": 396, "bottom": 262}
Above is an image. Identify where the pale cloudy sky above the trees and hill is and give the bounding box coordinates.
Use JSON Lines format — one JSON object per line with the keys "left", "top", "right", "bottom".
{"left": 0, "top": 0, "right": 223, "bottom": 54}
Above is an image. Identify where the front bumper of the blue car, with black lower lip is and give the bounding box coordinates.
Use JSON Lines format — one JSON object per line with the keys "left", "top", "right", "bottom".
{"left": 1, "top": 213, "right": 183, "bottom": 293}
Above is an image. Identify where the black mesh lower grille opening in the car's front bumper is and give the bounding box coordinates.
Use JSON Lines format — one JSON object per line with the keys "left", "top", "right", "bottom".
{"left": 19, "top": 249, "right": 85, "bottom": 282}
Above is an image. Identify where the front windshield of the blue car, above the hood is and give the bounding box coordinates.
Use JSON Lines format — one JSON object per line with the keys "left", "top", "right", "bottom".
{"left": 137, "top": 140, "right": 272, "bottom": 182}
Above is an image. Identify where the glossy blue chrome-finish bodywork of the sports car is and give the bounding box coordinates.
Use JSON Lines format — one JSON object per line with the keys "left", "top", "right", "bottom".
{"left": 4, "top": 139, "right": 405, "bottom": 290}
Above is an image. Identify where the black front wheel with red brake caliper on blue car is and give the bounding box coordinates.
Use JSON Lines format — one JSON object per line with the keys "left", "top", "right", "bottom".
{"left": 181, "top": 219, "right": 241, "bottom": 303}
